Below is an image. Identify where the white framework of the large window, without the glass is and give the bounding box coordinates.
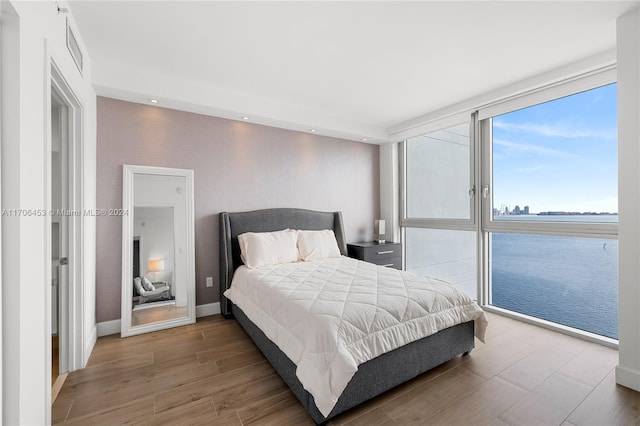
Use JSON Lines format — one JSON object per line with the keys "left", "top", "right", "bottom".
{"left": 398, "top": 63, "right": 620, "bottom": 348}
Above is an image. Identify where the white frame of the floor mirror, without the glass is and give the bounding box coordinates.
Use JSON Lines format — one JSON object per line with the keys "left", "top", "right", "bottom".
{"left": 120, "top": 164, "right": 196, "bottom": 337}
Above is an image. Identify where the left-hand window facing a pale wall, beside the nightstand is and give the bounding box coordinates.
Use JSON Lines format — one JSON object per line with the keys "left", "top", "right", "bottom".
{"left": 402, "top": 118, "right": 478, "bottom": 298}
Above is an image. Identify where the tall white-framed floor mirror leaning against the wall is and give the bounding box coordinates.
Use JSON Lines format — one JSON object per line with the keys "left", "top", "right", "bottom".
{"left": 121, "top": 164, "right": 196, "bottom": 337}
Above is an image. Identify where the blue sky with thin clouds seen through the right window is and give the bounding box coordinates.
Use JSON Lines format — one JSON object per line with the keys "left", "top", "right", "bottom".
{"left": 493, "top": 84, "right": 618, "bottom": 213}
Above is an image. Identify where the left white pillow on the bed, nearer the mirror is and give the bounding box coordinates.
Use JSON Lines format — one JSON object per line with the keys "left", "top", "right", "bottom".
{"left": 238, "top": 229, "right": 298, "bottom": 268}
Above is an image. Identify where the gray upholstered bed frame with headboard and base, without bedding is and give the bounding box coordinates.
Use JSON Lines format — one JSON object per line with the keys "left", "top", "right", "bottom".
{"left": 220, "top": 208, "right": 484, "bottom": 424}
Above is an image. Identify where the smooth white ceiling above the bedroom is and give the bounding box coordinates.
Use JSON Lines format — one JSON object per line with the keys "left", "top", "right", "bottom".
{"left": 69, "top": 1, "right": 638, "bottom": 143}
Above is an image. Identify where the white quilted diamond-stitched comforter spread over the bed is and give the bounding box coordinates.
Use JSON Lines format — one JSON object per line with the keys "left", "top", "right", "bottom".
{"left": 225, "top": 257, "right": 487, "bottom": 416}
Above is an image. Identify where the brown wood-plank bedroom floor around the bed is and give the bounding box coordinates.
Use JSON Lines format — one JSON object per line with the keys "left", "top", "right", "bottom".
{"left": 52, "top": 314, "right": 640, "bottom": 426}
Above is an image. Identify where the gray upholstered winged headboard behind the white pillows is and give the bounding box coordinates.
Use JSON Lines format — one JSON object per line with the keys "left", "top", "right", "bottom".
{"left": 220, "top": 208, "right": 347, "bottom": 317}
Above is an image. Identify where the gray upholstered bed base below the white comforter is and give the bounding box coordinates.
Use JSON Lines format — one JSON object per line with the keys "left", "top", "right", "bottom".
{"left": 229, "top": 303, "right": 474, "bottom": 424}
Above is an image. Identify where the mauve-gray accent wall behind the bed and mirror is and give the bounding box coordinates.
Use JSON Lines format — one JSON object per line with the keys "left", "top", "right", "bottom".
{"left": 96, "top": 97, "right": 380, "bottom": 322}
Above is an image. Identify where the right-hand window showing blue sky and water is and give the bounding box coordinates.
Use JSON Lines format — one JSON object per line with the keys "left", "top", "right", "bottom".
{"left": 488, "top": 84, "right": 618, "bottom": 339}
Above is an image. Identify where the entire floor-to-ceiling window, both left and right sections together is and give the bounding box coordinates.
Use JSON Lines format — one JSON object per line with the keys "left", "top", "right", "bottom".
{"left": 401, "top": 70, "right": 618, "bottom": 339}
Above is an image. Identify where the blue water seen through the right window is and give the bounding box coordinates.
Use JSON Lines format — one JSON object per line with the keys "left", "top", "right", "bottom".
{"left": 491, "top": 216, "right": 618, "bottom": 339}
